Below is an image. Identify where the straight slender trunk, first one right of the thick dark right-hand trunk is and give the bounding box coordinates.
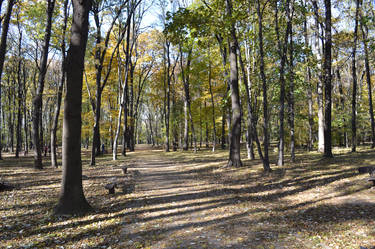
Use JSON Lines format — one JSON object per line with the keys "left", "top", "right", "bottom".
{"left": 352, "top": 0, "right": 359, "bottom": 152}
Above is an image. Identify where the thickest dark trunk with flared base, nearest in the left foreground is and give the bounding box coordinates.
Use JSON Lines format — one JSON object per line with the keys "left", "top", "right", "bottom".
{"left": 55, "top": 0, "right": 92, "bottom": 214}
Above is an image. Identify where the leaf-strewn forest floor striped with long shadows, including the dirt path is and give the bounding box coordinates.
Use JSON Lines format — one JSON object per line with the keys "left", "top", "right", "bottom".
{"left": 0, "top": 146, "right": 375, "bottom": 249}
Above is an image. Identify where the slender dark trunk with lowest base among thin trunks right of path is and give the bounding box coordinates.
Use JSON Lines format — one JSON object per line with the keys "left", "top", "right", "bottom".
{"left": 257, "top": 0, "right": 271, "bottom": 172}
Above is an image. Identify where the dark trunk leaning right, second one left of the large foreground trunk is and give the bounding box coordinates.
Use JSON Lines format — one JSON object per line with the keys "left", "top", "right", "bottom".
{"left": 32, "top": 0, "right": 55, "bottom": 169}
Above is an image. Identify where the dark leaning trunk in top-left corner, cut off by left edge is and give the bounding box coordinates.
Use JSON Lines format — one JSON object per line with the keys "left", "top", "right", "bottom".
{"left": 0, "top": 0, "right": 15, "bottom": 160}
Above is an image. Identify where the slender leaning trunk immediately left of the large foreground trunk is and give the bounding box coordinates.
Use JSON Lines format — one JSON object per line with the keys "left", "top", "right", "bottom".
{"left": 51, "top": 0, "right": 69, "bottom": 168}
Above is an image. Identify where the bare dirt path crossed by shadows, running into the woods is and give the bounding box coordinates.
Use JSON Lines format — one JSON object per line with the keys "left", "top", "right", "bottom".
{"left": 120, "top": 151, "right": 263, "bottom": 249}
